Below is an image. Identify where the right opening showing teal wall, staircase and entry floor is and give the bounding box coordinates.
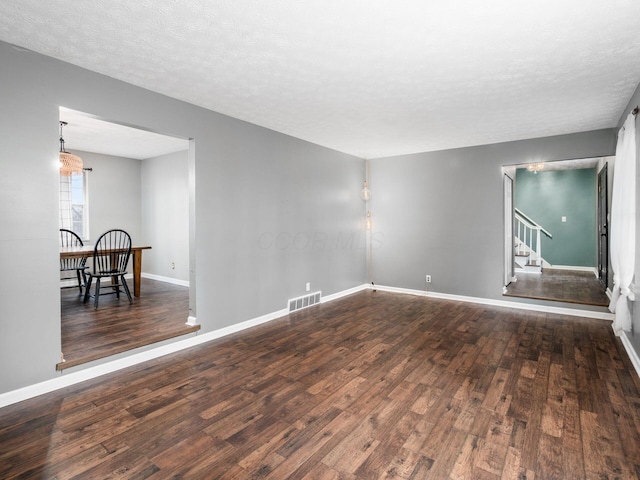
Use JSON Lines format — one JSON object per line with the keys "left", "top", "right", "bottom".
{"left": 503, "top": 157, "right": 613, "bottom": 307}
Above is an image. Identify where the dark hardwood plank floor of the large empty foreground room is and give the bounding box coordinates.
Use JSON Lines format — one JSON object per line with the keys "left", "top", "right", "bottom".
{"left": 5, "top": 291, "right": 640, "bottom": 480}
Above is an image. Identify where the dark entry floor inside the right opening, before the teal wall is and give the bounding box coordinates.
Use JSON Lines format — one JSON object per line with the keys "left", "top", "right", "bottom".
{"left": 505, "top": 269, "right": 609, "bottom": 307}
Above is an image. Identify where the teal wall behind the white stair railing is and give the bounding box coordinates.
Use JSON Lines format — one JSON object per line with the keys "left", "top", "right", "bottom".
{"left": 514, "top": 168, "right": 597, "bottom": 267}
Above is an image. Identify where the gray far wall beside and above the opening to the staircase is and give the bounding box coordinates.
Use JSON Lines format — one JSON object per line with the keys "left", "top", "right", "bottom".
{"left": 371, "top": 129, "right": 615, "bottom": 300}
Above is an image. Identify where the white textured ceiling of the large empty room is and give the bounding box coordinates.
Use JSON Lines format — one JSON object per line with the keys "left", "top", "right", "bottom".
{"left": 0, "top": 0, "right": 640, "bottom": 158}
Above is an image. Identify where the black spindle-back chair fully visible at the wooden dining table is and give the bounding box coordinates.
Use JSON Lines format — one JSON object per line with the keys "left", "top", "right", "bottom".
{"left": 84, "top": 229, "right": 133, "bottom": 309}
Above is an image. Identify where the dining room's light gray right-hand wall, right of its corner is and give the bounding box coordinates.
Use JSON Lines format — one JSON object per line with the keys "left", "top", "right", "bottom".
{"left": 141, "top": 150, "right": 189, "bottom": 282}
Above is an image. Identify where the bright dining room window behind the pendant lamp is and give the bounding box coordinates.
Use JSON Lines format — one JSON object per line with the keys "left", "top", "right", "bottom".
{"left": 60, "top": 171, "right": 89, "bottom": 240}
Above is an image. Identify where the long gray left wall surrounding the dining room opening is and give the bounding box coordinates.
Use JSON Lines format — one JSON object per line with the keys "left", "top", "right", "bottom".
{"left": 0, "top": 43, "right": 367, "bottom": 393}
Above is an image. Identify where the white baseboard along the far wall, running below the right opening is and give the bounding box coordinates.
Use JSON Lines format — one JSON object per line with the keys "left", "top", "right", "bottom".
{"left": 375, "top": 285, "right": 615, "bottom": 320}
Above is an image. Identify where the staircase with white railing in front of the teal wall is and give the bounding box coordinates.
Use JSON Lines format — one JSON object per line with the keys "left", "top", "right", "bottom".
{"left": 514, "top": 208, "right": 553, "bottom": 273}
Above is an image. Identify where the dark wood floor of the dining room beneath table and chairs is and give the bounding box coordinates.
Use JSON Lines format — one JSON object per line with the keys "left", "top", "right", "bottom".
{"left": 57, "top": 278, "right": 200, "bottom": 370}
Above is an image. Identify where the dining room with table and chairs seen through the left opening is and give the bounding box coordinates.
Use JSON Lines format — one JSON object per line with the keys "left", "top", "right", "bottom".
{"left": 56, "top": 107, "right": 200, "bottom": 371}
